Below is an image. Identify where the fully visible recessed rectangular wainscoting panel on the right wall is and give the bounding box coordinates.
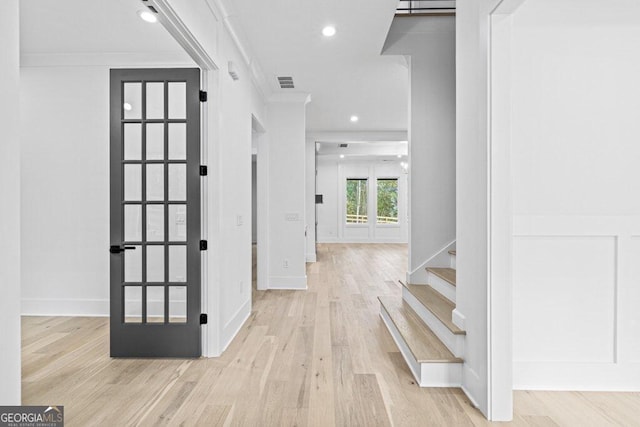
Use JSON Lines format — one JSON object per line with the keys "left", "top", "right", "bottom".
{"left": 513, "top": 236, "right": 616, "bottom": 363}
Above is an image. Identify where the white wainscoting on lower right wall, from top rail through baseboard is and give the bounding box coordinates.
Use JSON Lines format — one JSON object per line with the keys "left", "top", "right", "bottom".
{"left": 513, "top": 215, "right": 640, "bottom": 391}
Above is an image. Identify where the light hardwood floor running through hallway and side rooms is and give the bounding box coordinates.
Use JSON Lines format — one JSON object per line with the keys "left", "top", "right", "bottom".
{"left": 22, "top": 244, "right": 640, "bottom": 427}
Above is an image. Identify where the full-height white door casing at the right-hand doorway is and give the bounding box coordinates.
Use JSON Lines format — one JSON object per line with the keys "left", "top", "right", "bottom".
{"left": 487, "top": 0, "right": 526, "bottom": 421}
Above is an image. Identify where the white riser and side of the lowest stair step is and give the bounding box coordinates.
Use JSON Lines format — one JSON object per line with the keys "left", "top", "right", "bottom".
{"left": 380, "top": 306, "right": 462, "bottom": 387}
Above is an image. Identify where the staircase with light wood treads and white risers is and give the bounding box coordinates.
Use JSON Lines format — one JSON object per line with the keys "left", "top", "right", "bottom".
{"left": 378, "top": 251, "right": 466, "bottom": 387}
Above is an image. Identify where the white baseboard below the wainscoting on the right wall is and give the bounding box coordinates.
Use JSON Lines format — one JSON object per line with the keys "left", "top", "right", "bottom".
{"left": 513, "top": 361, "right": 640, "bottom": 392}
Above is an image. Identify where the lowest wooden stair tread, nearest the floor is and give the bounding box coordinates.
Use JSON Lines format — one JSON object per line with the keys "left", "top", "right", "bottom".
{"left": 378, "top": 297, "right": 462, "bottom": 363}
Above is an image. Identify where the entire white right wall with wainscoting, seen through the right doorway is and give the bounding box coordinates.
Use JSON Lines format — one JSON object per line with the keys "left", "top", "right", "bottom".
{"left": 509, "top": 0, "right": 640, "bottom": 391}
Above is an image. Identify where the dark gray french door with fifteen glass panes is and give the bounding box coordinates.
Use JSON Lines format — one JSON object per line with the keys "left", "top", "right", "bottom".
{"left": 109, "top": 69, "right": 201, "bottom": 357}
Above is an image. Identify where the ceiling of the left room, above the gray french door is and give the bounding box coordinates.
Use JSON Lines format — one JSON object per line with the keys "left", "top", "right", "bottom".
{"left": 20, "top": 0, "right": 188, "bottom": 58}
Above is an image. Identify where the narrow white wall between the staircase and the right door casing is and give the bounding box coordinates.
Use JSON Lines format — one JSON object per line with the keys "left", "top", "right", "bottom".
{"left": 456, "top": 0, "right": 512, "bottom": 420}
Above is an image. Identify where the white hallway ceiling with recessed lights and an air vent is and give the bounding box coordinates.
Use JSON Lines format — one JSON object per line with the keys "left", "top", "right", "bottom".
{"left": 225, "top": 0, "right": 409, "bottom": 131}
